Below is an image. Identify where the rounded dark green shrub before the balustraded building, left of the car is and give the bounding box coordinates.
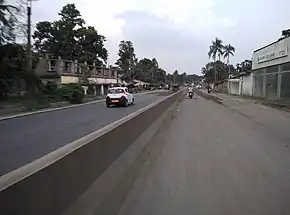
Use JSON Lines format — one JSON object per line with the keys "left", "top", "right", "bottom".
{"left": 58, "top": 84, "right": 85, "bottom": 104}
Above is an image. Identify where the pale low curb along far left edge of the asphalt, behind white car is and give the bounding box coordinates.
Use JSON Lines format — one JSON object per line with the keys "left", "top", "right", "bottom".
{"left": 0, "top": 91, "right": 163, "bottom": 121}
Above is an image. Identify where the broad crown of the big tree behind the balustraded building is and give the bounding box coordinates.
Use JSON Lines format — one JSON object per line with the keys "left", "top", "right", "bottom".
{"left": 33, "top": 4, "right": 108, "bottom": 65}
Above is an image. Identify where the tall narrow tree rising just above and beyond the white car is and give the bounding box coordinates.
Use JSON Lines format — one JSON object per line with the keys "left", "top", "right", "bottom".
{"left": 115, "top": 40, "right": 137, "bottom": 80}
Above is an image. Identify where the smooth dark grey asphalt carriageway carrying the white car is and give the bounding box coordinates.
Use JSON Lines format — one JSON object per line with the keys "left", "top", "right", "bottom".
{"left": 0, "top": 92, "right": 168, "bottom": 175}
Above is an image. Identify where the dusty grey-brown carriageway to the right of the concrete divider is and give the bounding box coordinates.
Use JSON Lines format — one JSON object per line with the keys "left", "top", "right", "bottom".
{"left": 118, "top": 97, "right": 290, "bottom": 215}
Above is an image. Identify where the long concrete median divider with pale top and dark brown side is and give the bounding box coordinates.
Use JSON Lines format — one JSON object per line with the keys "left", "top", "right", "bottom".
{"left": 0, "top": 90, "right": 185, "bottom": 215}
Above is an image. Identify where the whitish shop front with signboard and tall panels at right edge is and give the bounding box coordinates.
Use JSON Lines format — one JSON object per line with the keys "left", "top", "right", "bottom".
{"left": 252, "top": 37, "right": 290, "bottom": 103}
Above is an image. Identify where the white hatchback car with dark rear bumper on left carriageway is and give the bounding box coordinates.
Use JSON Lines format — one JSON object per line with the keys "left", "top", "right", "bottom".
{"left": 106, "top": 87, "right": 135, "bottom": 108}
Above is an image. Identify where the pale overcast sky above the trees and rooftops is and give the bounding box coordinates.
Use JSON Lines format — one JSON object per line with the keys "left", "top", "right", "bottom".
{"left": 28, "top": 0, "right": 290, "bottom": 74}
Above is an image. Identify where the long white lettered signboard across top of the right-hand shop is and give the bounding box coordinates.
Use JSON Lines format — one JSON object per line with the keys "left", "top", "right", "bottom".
{"left": 252, "top": 37, "right": 290, "bottom": 70}
